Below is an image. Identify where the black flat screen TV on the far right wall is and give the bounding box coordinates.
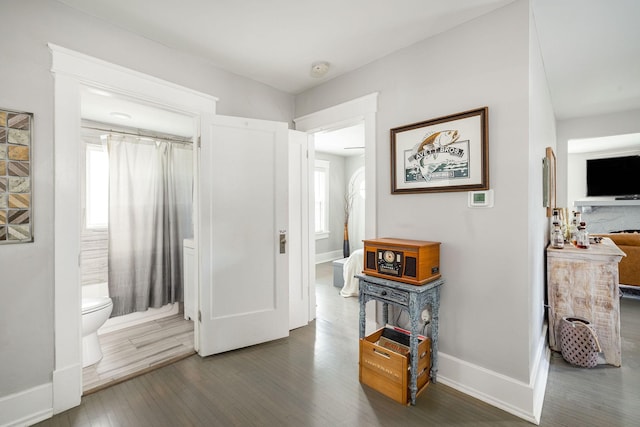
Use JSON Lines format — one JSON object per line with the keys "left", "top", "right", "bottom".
{"left": 587, "top": 156, "right": 640, "bottom": 199}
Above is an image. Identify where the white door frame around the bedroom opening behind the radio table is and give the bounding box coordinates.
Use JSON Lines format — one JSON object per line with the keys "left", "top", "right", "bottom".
{"left": 293, "top": 92, "right": 378, "bottom": 320}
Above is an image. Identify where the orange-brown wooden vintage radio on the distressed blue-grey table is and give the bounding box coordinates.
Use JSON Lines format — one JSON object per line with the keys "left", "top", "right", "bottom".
{"left": 363, "top": 237, "right": 440, "bottom": 285}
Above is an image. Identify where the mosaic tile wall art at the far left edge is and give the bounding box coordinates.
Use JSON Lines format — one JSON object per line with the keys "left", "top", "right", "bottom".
{"left": 0, "top": 109, "right": 33, "bottom": 244}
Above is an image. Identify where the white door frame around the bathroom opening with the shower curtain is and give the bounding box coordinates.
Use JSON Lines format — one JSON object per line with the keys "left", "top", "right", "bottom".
{"left": 48, "top": 43, "right": 218, "bottom": 414}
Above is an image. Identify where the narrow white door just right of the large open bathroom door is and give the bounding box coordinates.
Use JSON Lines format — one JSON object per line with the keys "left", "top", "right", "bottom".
{"left": 289, "top": 130, "right": 311, "bottom": 329}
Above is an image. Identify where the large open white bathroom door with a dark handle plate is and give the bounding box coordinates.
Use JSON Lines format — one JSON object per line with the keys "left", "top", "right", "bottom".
{"left": 198, "top": 116, "right": 289, "bottom": 356}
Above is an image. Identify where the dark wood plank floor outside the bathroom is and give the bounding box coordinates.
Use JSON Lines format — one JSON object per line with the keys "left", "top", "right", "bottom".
{"left": 40, "top": 264, "right": 640, "bottom": 427}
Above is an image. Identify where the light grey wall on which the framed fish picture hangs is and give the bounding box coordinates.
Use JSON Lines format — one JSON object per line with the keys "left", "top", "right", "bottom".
{"left": 296, "top": 1, "right": 553, "bottom": 422}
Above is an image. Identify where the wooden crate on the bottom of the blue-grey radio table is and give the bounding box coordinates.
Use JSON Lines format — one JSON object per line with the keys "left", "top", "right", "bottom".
{"left": 360, "top": 329, "right": 431, "bottom": 405}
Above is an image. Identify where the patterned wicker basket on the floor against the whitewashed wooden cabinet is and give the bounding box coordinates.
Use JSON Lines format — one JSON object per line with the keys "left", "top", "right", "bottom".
{"left": 560, "top": 317, "right": 602, "bottom": 368}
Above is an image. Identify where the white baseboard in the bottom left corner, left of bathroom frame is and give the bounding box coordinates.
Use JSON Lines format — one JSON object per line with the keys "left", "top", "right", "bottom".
{"left": 0, "top": 383, "right": 53, "bottom": 427}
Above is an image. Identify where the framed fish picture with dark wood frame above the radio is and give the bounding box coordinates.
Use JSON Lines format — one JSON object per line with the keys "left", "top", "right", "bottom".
{"left": 391, "top": 107, "right": 489, "bottom": 194}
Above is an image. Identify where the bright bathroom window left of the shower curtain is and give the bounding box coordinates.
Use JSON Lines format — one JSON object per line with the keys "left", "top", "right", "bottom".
{"left": 85, "top": 145, "right": 109, "bottom": 230}
